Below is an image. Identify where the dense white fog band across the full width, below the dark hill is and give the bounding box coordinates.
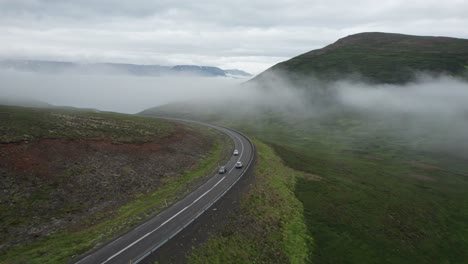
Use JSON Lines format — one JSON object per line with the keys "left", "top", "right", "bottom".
{"left": 0, "top": 71, "right": 468, "bottom": 117}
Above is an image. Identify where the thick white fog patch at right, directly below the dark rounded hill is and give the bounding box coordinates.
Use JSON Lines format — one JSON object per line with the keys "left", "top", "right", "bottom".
{"left": 335, "top": 76, "right": 468, "bottom": 118}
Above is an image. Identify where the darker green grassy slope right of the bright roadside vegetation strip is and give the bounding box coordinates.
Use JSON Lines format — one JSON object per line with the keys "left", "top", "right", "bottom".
{"left": 245, "top": 120, "right": 468, "bottom": 263}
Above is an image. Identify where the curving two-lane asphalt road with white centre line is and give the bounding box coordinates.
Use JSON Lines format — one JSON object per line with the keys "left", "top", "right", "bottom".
{"left": 75, "top": 119, "right": 254, "bottom": 264}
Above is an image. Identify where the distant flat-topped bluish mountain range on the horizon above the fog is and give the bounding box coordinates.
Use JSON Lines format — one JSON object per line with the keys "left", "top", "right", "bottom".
{"left": 0, "top": 60, "right": 252, "bottom": 78}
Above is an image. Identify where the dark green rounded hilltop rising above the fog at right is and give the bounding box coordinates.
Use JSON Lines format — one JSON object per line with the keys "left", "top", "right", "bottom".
{"left": 253, "top": 32, "right": 468, "bottom": 83}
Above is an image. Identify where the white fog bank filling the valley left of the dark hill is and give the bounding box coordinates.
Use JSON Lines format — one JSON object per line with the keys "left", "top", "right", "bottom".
{"left": 0, "top": 71, "right": 245, "bottom": 114}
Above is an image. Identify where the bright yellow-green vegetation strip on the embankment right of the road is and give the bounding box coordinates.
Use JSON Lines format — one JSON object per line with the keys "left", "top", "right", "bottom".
{"left": 189, "top": 141, "right": 313, "bottom": 263}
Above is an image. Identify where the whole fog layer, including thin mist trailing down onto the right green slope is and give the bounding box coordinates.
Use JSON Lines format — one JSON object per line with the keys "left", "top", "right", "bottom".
{"left": 0, "top": 71, "right": 468, "bottom": 156}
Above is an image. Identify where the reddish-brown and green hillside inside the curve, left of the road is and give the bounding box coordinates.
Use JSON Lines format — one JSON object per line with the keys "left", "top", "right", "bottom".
{"left": 0, "top": 105, "right": 231, "bottom": 263}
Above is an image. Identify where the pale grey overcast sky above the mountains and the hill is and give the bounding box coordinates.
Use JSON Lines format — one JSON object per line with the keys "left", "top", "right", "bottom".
{"left": 0, "top": 0, "right": 468, "bottom": 74}
